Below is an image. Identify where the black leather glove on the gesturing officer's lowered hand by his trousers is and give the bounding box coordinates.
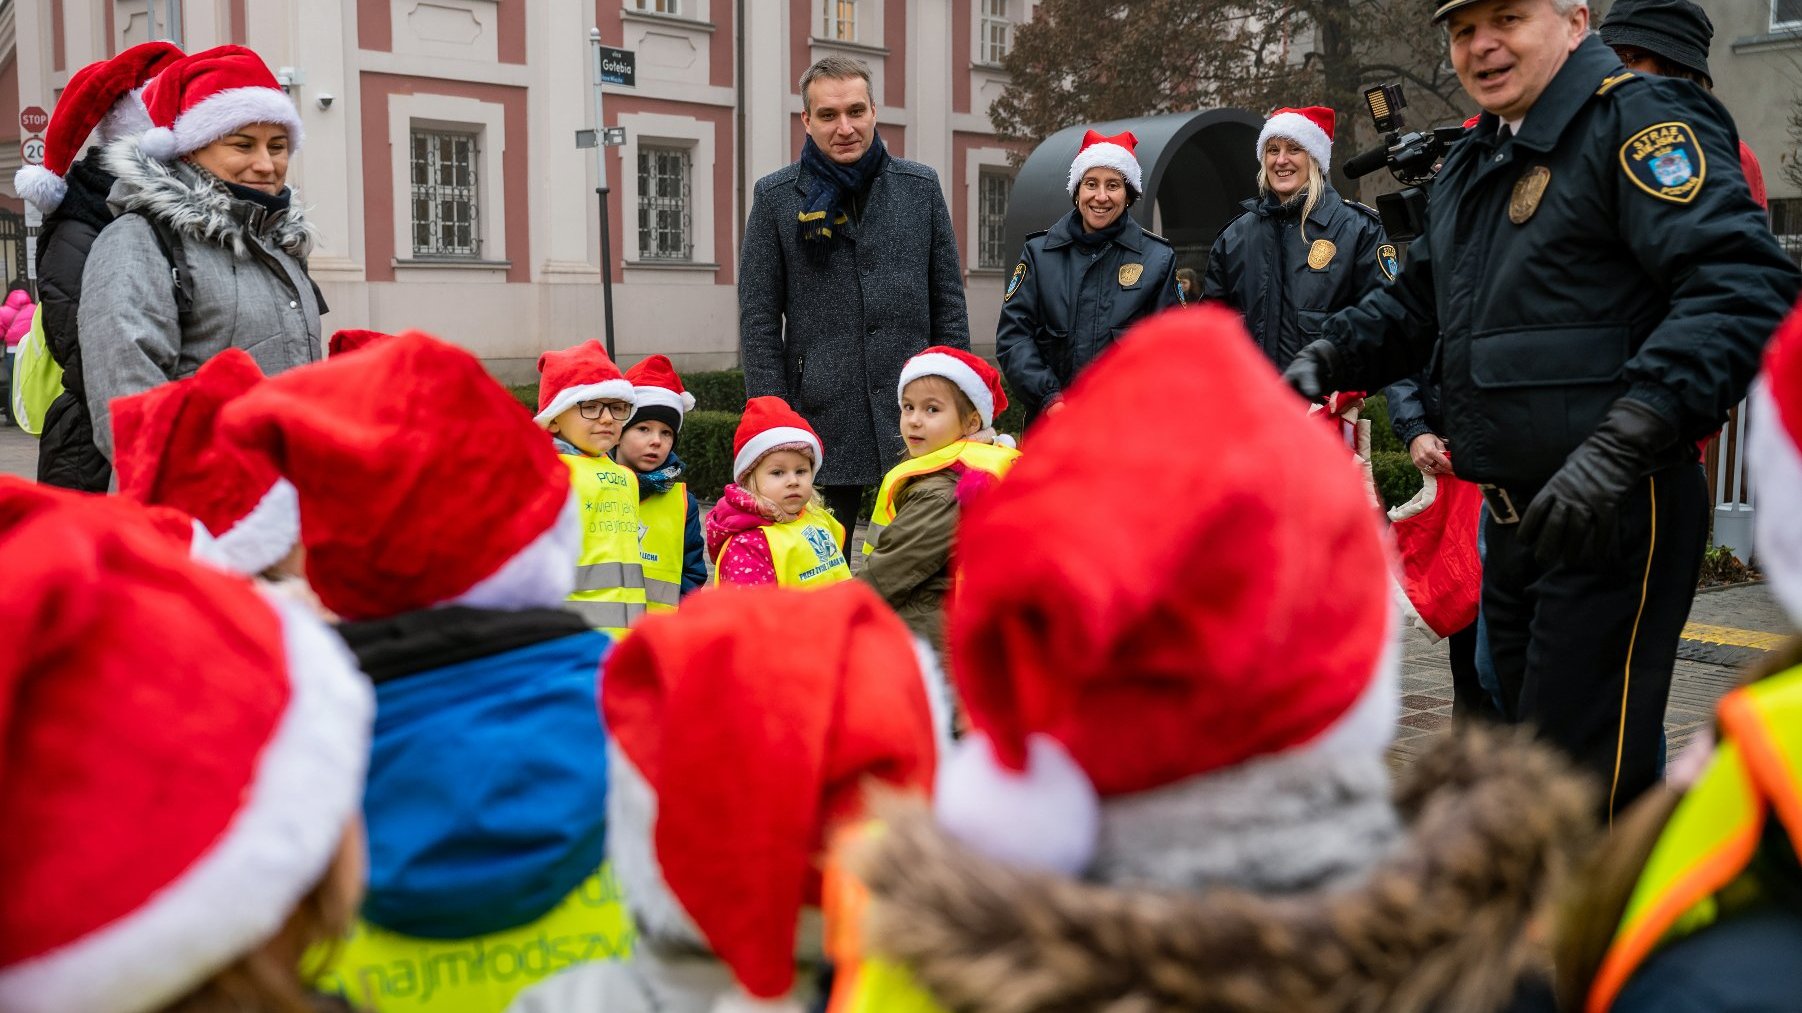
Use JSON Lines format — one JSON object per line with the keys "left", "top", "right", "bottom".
{"left": 1521, "top": 398, "right": 1678, "bottom": 568}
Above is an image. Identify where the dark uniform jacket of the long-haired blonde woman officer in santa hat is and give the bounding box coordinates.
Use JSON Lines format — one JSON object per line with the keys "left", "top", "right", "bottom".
{"left": 1202, "top": 187, "right": 1397, "bottom": 370}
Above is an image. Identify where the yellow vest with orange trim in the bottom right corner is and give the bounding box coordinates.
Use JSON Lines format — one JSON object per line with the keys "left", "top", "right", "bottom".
{"left": 1588, "top": 667, "right": 1802, "bottom": 1013}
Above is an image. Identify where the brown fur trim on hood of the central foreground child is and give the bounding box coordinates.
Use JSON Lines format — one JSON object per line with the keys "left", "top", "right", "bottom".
{"left": 852, "top": 730, "right": 1595, "bottom": 1013}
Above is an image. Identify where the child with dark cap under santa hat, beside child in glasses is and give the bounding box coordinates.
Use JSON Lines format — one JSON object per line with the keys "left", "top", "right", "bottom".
{"left": 613, "top": 355, "right": 706, "bottom": 613}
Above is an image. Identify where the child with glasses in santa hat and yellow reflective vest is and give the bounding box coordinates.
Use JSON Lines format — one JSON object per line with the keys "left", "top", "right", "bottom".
{"left": 533, "top": 339, "right": 645, "bottom": 638}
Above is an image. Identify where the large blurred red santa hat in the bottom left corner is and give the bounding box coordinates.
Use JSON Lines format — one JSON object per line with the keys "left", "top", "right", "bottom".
{"left": 0, "top": 481, "right": 373, "bottom": 1011}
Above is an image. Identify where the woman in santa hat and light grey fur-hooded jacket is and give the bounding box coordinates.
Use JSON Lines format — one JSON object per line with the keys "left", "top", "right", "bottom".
{"left": 79, "top": 45, "right": 326, "bottom": 460}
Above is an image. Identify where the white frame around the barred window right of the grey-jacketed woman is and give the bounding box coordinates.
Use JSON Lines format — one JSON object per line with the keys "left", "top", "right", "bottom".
{"left": 387, "top": 94, "right": 508, "bottom": 268}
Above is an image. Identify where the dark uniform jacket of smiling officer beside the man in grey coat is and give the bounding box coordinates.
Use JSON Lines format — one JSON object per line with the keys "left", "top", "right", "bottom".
{"left": 995, "top": 209, "right": 1182, "bottom": 413}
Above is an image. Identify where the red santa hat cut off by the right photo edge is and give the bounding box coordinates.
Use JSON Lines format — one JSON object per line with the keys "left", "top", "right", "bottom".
{"left": 1750, "top": 299, "right": 1802, "bottom": 624}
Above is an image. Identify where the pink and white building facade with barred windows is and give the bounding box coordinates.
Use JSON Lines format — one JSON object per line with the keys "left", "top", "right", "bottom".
{"left": 0, "top": 0, "right": 1033, "bottom": 380}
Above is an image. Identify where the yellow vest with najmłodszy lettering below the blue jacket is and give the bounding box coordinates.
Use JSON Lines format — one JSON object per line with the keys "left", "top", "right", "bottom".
{"left": 317, "top": 865, "right": 634, "bottom": 1013}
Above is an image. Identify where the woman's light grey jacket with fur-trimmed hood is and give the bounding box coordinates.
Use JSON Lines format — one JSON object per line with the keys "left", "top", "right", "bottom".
{"left": 79, "top": 137, "right": 324, "bottom": 460}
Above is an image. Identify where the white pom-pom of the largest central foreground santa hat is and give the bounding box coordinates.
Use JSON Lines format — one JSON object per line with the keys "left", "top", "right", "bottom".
{"left": 933, "top": 732, "right": 1101, "bottom": 876}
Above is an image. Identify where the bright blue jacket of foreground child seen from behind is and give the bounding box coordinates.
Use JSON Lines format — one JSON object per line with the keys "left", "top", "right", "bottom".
{"left": 339, "top": 607, "right": 613, "bottom": 939}
